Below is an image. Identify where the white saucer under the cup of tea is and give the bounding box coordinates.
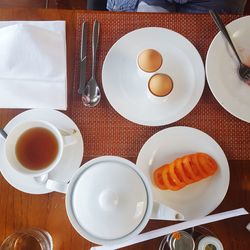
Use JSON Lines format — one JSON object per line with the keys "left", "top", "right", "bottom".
{"left": 0, "top": 109, "right": 83, "bottom": 194}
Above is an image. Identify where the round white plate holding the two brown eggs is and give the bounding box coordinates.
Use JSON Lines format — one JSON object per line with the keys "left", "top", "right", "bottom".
{"left": 102, "top": 27, "right": 205, "bottom": 126}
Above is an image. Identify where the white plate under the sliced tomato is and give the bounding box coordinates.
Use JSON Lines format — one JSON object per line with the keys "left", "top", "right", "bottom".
{"left": 136, "top": 127, "right": 230, "bottom": 220}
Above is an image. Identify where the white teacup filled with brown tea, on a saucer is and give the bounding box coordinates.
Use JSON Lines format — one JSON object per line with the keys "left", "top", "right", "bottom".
{"left": 4, "top": 120, "right": 76, "bottom": 179}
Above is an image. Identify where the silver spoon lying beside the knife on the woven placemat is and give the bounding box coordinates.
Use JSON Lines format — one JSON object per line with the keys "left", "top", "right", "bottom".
{"left": 82, "top": 20, "right": 101, "bottom": 107}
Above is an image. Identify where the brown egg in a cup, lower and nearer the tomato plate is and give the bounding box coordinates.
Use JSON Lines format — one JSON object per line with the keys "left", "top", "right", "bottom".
{"left": 148, "top": 74, "right": 173, "bottom": 97}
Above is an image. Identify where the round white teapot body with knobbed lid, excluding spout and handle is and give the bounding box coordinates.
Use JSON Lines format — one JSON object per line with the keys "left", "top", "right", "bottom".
{"left": 66, "top": 156, "right": 152, "bottom": 245}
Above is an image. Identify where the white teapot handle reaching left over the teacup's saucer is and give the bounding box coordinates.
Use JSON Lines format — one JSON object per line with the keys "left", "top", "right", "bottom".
{"left": 34, "top": 174, "right": 69, "bottom": 194}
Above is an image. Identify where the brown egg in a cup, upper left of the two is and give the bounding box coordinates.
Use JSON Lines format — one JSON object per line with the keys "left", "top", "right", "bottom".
{"left": 138, "top": 49, "right": 162, "bottom": 72}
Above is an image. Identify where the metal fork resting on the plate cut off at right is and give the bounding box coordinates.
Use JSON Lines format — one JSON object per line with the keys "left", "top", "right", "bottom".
{"left": 209, "top": 10, "right": 250, "bottom": 85}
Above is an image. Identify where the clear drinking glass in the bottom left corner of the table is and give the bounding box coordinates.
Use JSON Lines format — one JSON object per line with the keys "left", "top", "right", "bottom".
{"left": 0, "top": 228, "right": 53, "bottom": 250}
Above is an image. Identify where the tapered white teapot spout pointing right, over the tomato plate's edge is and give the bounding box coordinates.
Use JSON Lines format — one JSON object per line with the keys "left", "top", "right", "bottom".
{"left": 151, "top": 201, "right": 185, "bottom": 221}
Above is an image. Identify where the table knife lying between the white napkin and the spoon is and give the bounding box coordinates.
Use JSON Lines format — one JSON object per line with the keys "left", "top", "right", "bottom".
{"left": 78, "top": 22, "right": 87, "bottom": 94}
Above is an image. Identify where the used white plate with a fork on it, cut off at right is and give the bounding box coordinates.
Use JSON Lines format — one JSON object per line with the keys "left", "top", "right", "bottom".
{"left": 206, "top": 16, "right": 250, "bottom": 122}
